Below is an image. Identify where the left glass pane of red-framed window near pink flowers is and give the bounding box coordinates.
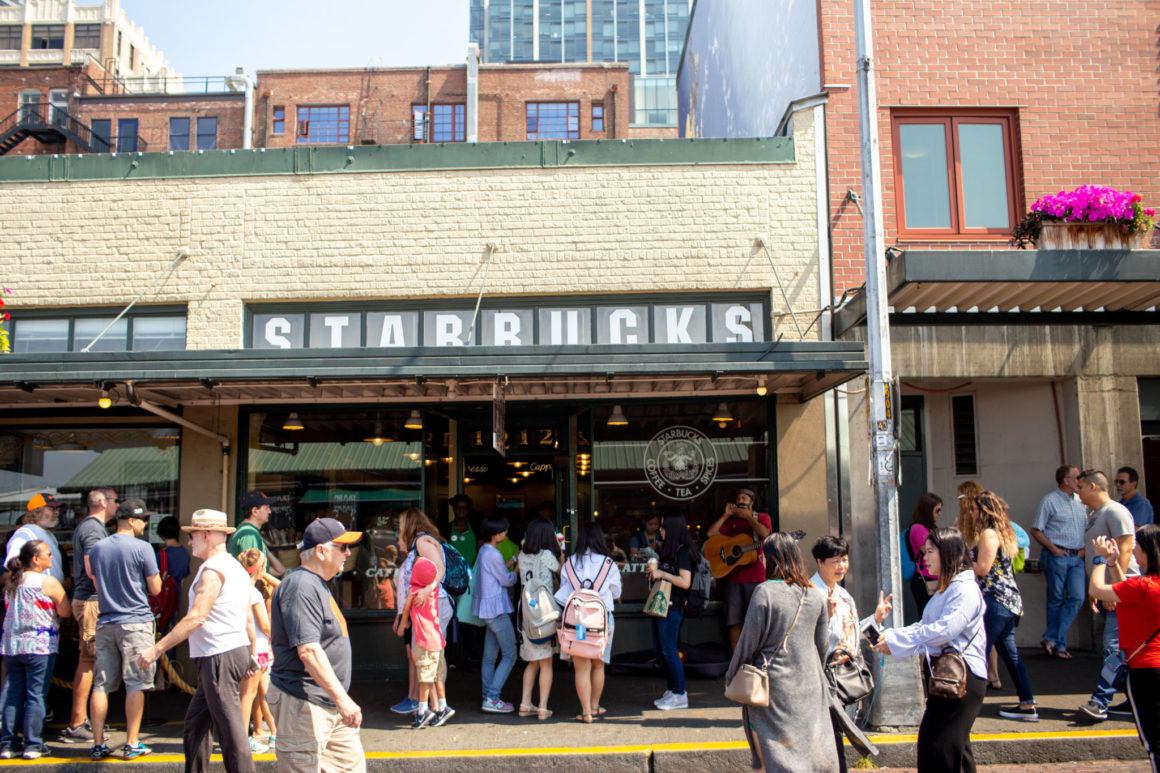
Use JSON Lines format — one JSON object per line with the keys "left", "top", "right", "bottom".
{"left": 898, "top": 123, "right": 950, "bottom": 229}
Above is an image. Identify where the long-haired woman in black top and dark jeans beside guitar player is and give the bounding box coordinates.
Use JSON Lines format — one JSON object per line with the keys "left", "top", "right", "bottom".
{"left": 648, "top": 513, "right": 696, "bottom": 711}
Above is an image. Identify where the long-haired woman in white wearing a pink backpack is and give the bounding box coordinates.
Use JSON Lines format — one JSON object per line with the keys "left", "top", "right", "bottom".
{"left": 556, "top": 521, "right": 621, "bottom": 723}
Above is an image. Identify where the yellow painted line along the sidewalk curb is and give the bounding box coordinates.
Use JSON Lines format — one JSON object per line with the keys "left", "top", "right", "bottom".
{"left": 0, "top": 730, "right": 1136, "bottom": 767}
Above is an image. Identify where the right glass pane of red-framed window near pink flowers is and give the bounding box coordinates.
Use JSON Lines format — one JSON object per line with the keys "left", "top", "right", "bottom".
{"left": 958, "top": 123, "right": 1010, "bottom": 229}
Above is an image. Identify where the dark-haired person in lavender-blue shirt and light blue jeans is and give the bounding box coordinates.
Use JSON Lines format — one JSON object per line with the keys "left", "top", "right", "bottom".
{"left": 471, "top": 515, "right": 516, "bottom": 714}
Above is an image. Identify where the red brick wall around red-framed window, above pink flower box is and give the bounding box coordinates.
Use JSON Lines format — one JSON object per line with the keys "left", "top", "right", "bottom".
{"left": 818, "top": 0, "right": 1160, "bottom": 295}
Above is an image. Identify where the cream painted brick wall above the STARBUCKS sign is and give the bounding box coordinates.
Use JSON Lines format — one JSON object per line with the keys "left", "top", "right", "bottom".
{"left": 0, "top": 114, "right": 819, "bottom": 349}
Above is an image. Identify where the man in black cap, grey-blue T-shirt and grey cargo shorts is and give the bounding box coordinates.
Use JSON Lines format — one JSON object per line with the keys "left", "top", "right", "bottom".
{"left": 88, "top": 499, "right": 161, "bottom": 759}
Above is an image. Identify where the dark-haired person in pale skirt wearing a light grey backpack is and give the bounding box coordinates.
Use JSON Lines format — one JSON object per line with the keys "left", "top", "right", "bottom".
{"left": 517, "top": 518, "right": 561, "bottom": 720}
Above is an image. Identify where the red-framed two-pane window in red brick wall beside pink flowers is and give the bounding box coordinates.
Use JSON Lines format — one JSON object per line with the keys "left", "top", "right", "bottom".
{"left": 892, "top": 110, "right": 1018, "bottom": 238}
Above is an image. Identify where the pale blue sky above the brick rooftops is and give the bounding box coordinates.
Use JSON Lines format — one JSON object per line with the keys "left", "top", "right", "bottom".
{"left": 121, "top": 0, "right": 467, "bottom": 75}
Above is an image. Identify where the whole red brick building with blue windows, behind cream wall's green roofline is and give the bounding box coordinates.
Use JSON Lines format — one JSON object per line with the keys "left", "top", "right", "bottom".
{"left": 254, "top": 64, "right": 630, "bottom": 147}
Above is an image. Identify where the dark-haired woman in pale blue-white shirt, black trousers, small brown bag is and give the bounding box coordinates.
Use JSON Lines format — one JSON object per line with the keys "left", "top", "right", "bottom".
{"left": 875, "top": 529, "right": 987, "bottom": 773}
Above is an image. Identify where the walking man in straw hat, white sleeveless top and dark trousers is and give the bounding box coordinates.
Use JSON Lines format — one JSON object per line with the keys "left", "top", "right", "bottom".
{"left": 137, "top": 510, "right": 258, "bottom": 773}
